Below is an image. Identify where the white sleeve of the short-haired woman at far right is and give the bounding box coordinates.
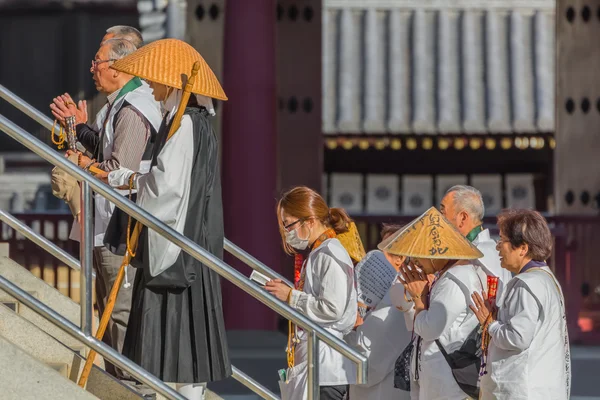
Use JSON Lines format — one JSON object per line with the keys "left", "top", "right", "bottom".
{"left": 488, "top": 279, "right": 540, "bottom": 351}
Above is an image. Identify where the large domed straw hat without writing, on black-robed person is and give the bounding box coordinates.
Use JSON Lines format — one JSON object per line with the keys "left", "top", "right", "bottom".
{"left": 111, "top": 39, "right": 227, "bottom": 100}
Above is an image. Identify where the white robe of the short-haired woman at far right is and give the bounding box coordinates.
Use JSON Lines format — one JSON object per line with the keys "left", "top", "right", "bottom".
{"left": 481, "top": 267, "right": 571, "bottom": 400}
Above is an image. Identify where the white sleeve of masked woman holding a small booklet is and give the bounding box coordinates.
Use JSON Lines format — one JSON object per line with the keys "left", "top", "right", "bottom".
{"left": 290, "top": 253, "right": 354, "bottom": 323}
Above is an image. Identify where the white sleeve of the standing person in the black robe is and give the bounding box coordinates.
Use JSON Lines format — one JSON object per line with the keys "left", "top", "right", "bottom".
{"left": 137, "top": 115, "right": 194, "bottom": 276}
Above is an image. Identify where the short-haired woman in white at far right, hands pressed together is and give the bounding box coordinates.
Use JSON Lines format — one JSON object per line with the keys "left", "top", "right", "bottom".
{"left": 471, "top": 210, "right": 571, "bottom": 400}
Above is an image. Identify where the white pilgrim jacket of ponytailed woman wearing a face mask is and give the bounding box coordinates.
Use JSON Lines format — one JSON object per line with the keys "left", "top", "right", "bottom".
{"left": 280, "top": 238, "right": 358, "bottom": 400}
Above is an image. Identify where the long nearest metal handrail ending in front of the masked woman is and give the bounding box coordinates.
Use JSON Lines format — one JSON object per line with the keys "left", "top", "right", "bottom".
{"left": 0, "top": 86, "right": 367, "bottom": 399}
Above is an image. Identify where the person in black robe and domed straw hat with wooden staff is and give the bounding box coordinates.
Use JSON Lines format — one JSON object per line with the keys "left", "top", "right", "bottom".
{"left": 101, "top": 39, "right": 231, "bottom": 399}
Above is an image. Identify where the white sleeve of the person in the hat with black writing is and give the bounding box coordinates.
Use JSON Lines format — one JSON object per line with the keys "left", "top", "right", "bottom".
{"left": 414, "top": 279, "right": 467, "bottom": 341}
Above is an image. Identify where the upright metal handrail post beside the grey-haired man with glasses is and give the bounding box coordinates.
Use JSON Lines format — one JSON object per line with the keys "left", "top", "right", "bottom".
{"left": 79, "top": 181, "right": 94, "bottom": 336}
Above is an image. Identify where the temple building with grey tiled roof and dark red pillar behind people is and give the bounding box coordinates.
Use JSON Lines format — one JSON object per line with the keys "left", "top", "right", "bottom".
{"left": 0, "top": 0, "right": 600, "bottom": 354}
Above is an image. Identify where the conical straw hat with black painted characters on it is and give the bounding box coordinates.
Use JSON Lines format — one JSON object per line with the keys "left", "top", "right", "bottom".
{"left": 378, "top": 207, "right": 483, "bottom": 260}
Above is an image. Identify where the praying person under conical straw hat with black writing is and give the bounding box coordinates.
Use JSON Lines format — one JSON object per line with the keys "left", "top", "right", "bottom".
{"left": 379, "top": 207, "right": 487, "bottom": 400}
